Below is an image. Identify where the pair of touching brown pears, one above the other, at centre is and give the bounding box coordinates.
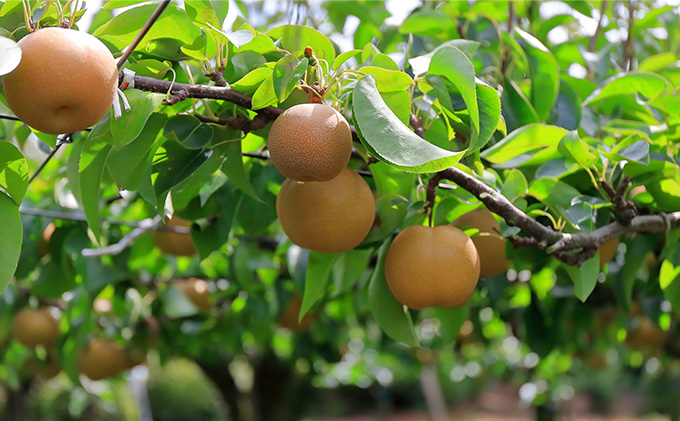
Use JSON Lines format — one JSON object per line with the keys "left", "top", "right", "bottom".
{"left": 268, "top": 104, "right": 375, "bottom": 252}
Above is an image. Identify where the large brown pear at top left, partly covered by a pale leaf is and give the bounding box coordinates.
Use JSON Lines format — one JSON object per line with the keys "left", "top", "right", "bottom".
{"left": 2, "top": 27, "right": 118, "bottom": 134}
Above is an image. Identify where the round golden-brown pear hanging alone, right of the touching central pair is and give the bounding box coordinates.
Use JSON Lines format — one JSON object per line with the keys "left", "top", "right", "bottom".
{"left": 385, "top": 225, "right": 480, "bottom": 310}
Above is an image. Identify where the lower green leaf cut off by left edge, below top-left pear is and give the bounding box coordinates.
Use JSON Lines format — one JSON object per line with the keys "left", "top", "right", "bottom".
{"left": 0, "top": 192, "right": 23, "bottom": 292}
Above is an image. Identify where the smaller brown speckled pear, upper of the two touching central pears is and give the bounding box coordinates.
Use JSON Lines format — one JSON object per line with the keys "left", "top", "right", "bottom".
{"left": 268, "top": 104, "right": 352, "bottom": 181}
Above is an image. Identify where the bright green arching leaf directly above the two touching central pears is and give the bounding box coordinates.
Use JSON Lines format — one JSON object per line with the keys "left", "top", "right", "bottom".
{"left": 267, "top": 25, "right": 335, "bottom": 63}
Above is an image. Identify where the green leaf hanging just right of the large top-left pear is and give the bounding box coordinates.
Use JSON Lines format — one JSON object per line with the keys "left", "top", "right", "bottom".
{"left": 109, "top": 89, "right": 163, "bottom": 149}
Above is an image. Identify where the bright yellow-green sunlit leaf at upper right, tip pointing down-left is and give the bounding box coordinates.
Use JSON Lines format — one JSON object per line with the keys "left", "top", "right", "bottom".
{"left": 583, "top": 71, "right": 671, "bottom": 105}
